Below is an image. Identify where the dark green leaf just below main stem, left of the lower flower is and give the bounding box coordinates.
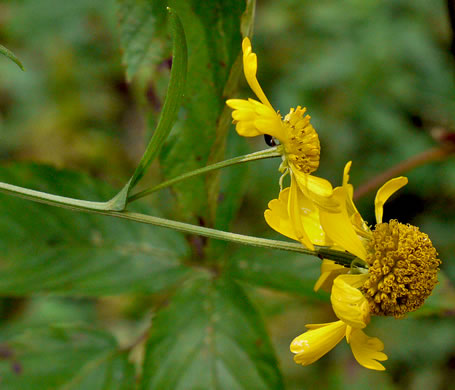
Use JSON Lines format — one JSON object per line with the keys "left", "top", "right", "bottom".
{"left": 227, "top": 247, "right": 326, "bottom": 299}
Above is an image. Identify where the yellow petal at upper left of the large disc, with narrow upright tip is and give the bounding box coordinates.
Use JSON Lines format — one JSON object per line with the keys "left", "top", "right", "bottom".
{"left": 320, "top": 187, "right": 367, "bottom": 260}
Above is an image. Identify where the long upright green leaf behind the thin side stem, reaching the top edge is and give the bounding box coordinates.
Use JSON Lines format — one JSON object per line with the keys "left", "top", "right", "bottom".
{"left": 160, "top": 0, "right": 246, "bottom": 226}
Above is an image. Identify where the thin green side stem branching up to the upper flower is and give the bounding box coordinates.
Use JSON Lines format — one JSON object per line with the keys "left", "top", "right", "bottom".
{"left": 128, "top": 146, "right": 281, "bottom": 203}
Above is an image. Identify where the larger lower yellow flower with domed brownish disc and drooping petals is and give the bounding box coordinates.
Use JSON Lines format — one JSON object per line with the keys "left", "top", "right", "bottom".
{"left": 265, "top": 162, "right": 440, "bottom": 370}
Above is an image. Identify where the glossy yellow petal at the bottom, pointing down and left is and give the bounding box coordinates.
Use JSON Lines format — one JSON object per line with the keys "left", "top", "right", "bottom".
{"left": 290, "top": 321, "right": 347, "bottom": 366}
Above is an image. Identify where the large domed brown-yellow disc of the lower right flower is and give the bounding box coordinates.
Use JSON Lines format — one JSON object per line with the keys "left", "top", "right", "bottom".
{"left": 362, "top": 220, "right": 441, "bottom": 318}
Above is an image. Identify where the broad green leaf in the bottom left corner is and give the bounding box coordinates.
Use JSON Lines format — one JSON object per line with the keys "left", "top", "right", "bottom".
{"left": 0, "top": 326, "right": 135, "bottom": 390}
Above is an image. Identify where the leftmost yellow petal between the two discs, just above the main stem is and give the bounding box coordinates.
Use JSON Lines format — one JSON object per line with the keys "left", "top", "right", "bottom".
{"left": 264, "top": 187, "right": 298, "bottom": 241}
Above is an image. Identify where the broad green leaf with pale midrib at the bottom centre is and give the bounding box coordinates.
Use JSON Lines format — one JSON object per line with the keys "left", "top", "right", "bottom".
{"left": 140, "top": 278, "right": 284, "bottom": 390}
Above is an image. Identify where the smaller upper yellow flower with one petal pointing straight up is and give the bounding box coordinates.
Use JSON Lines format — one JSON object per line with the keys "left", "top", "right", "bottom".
{"left": 226, "top": 38, "right": 335, "bottom": 213}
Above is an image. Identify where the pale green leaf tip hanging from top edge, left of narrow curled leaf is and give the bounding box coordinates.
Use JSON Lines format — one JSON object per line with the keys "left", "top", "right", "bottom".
{"left": 117, "top": 0, "right": 166, "bottom": 81}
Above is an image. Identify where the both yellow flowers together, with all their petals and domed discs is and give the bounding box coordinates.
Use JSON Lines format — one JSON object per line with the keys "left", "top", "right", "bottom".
{"left": 226, "top": 38, "right": 440, "bottom": 370}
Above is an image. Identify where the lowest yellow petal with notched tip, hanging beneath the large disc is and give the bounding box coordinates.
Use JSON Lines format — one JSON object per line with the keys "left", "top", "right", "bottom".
{"left": 348, "top": 329, "right": 387, "bottom": 371}
